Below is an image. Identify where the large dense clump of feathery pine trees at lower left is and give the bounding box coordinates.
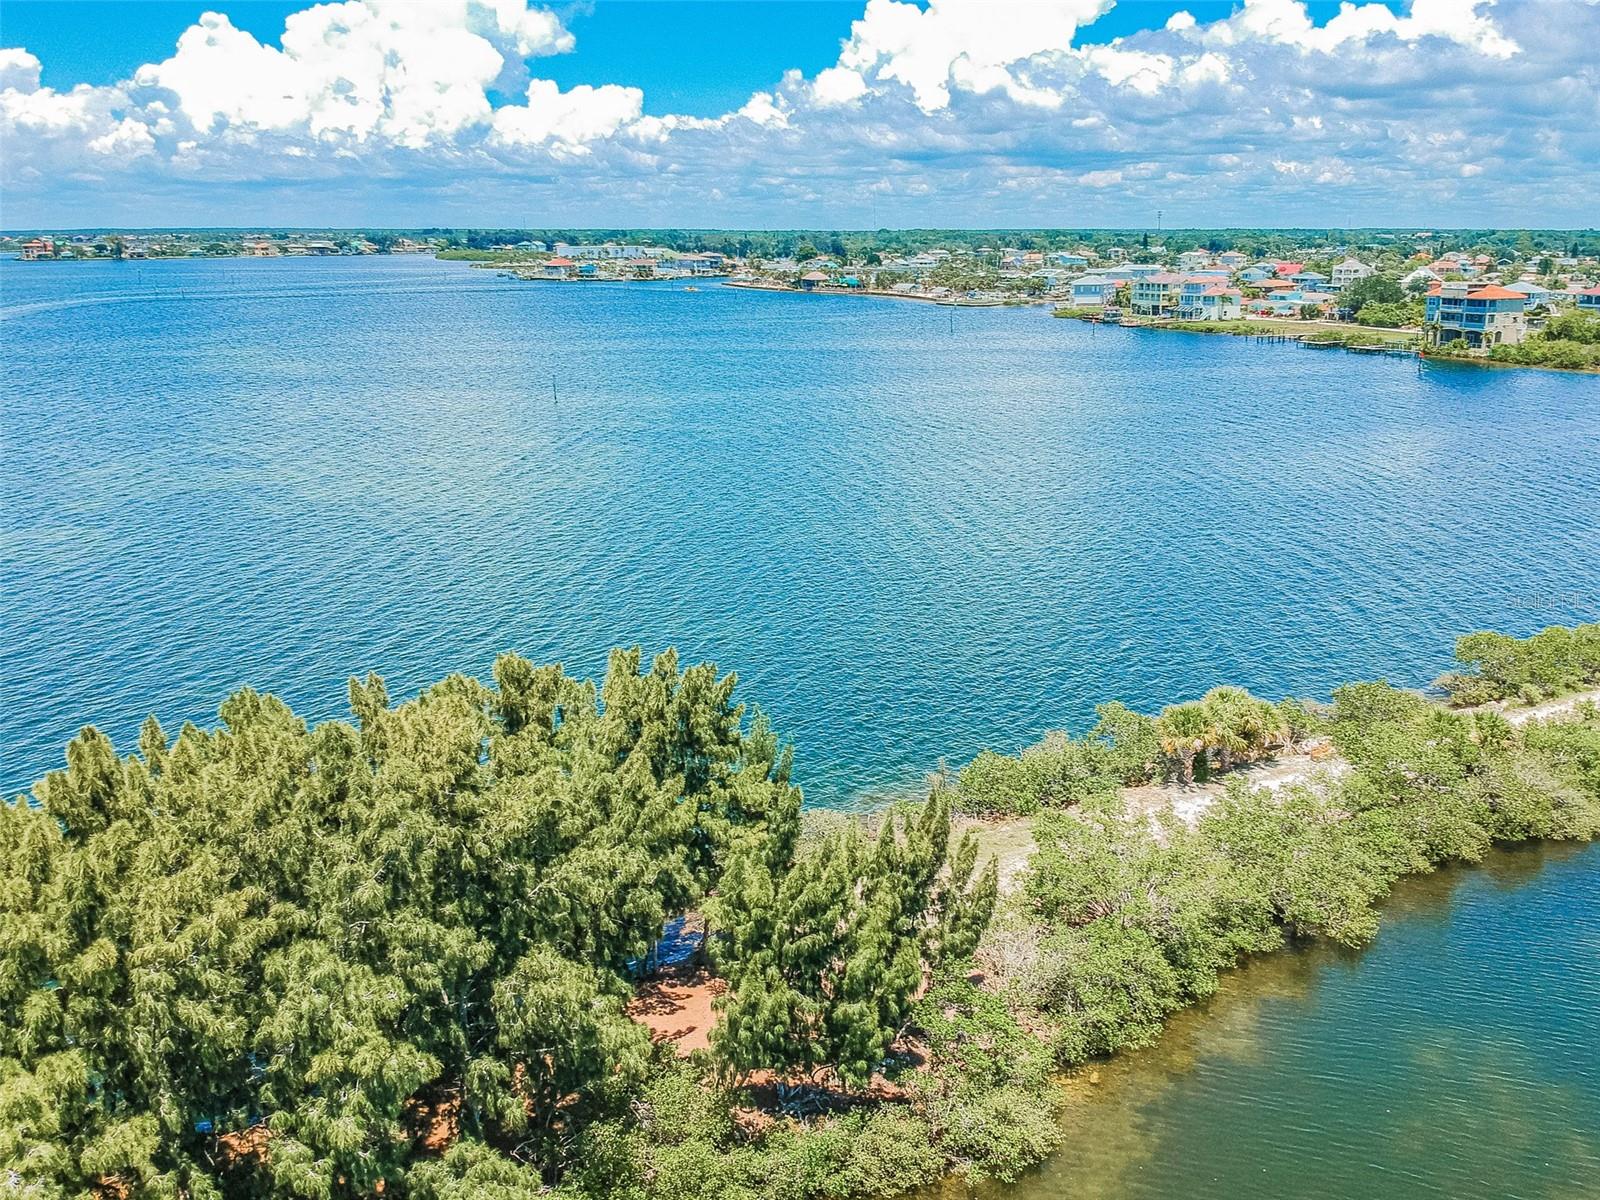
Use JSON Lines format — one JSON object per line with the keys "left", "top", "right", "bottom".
{"left": 0, "top": 650, "right": 800, "bottom": 1198}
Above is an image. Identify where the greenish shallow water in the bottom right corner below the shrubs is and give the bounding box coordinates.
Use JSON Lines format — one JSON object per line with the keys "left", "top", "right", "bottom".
{"left": 985, "top": 845, "right": 1600, "bottom": 1200}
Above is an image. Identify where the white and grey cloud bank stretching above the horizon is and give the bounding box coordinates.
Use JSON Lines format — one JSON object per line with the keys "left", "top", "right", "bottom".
{"left": 0, "top": 0, "right": 1600, "bottom": 227}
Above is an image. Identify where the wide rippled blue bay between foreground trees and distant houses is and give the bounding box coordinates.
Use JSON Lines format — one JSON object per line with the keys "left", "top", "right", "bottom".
{"left": 0, "top": 258, "right": 1600, "bottom": 805}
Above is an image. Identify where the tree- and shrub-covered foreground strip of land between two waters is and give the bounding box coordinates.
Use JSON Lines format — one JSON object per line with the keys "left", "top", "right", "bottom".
{"left": 12, "top": 624, "right": 1600, "bottom": 1200}
